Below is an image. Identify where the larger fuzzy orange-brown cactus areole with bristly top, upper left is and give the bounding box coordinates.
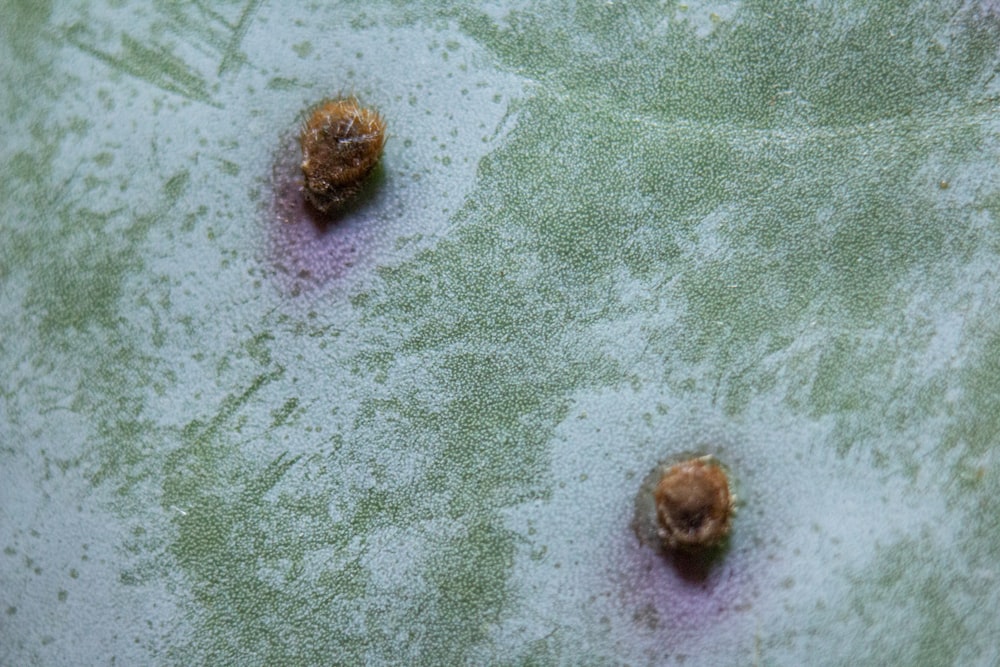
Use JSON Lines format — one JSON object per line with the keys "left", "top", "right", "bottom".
{"left": 299, "top": 97, "right": 386, "bottom": 213}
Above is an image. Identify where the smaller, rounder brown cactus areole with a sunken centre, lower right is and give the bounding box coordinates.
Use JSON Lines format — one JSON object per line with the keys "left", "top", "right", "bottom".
{"left": 653, "top": 456, "right": 734, "bottom": 553}
